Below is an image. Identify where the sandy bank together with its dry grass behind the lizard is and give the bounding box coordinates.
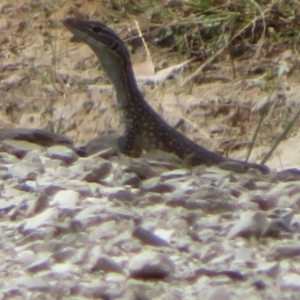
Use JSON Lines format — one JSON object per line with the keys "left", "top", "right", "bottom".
{"left": 0, "top": 0, "right": 299, "bottom": 166}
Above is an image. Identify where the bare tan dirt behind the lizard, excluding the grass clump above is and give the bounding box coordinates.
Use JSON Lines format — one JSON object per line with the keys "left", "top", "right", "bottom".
{"left": 0, "top": 0, "right": 300, "bottom": 170}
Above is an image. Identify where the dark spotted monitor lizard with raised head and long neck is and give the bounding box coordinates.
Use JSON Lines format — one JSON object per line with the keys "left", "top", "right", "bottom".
{"left": 63, "top": 19, "right": 269, "bottom": 173}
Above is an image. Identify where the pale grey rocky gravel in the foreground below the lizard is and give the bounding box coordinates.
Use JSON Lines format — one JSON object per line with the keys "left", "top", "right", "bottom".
{"left": 0, "top": 141, "right": 300, "bottom": 299}
